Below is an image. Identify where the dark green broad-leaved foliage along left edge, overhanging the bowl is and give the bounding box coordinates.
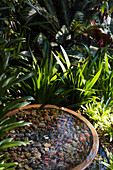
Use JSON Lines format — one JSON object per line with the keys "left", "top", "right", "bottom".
{"left": 0, "top": 2, "right": 33, "bottom": 169}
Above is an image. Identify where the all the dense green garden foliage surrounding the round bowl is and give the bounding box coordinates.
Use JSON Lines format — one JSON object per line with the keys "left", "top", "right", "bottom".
{"left": 0, "top": 0, "right": 113, "bottom": 170}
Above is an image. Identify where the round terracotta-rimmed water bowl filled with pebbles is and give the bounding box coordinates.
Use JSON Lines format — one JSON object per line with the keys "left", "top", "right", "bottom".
{"left": 4, "top": 104, "right": 99, "bottom": 170}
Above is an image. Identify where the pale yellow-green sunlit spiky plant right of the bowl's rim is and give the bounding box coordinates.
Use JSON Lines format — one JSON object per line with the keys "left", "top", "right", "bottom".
{"left": 82, "top": 97, "right": 113, "bottom": 142}
